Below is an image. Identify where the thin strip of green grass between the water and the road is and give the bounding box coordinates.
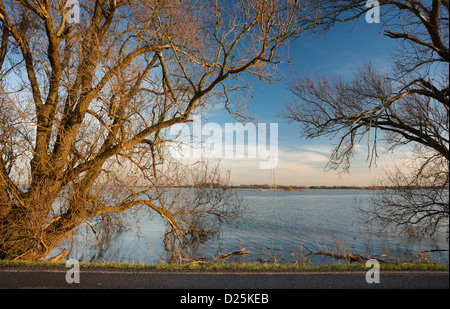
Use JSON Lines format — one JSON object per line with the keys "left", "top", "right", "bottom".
{"left": 0, "top": 261, "right": 449, "bottom": 271}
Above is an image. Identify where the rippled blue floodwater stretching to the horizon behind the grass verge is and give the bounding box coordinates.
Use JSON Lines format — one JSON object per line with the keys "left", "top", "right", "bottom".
{"left": 63, "top": 189, "right": 449, "bottom": 265}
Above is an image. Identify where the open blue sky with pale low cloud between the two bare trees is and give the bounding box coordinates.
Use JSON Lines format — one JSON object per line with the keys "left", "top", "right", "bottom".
{"left": 201, "top": 18, "right": 404, "bottom": 186}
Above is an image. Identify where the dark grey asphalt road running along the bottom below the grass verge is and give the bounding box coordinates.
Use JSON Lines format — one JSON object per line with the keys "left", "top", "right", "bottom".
{"left": 0, "top": 267, "right": 449, "bottom": 288}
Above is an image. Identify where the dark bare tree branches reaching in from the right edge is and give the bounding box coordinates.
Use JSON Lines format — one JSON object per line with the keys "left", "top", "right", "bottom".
{"left": 283, "top": 0, "right": 449, "bottom": 233}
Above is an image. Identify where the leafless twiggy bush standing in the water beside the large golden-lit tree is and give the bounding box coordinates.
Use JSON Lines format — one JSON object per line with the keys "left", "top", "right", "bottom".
{"left": 161, "top": 164, "right": 243, "bottom": 263}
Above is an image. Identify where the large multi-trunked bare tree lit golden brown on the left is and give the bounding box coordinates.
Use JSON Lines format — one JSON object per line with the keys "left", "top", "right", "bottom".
{"left": 0, "top": 0, "right": 313, "bottom": 260}
